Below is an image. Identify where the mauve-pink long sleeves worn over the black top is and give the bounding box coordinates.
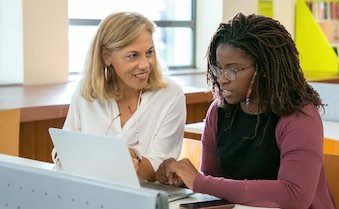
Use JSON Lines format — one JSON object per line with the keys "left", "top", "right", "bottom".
{"left": 193, "top": 101, "right": 336, "bottom": 209}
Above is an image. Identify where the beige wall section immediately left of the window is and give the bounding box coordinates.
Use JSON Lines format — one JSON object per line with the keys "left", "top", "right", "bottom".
{"left": 23, "top": 0, "right": 68, "bottom": 85}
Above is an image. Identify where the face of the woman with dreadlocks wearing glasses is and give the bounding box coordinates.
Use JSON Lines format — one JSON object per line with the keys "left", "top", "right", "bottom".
{"left": 216, "top": 44, "right": 255, "bottom": 104}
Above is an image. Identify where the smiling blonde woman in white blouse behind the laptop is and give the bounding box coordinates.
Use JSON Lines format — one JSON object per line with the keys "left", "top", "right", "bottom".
{"left": 52, "top": 12, "right": 186, "bottom": 181}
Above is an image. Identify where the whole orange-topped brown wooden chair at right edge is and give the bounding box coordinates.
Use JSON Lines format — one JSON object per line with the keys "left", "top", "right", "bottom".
{"left": 324, "top": 138, "right": 339, "bottom": 207}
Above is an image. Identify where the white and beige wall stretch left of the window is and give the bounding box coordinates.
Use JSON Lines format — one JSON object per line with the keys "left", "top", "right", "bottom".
{"left": 0, "top": 0, "right": 68, "bottom": 85}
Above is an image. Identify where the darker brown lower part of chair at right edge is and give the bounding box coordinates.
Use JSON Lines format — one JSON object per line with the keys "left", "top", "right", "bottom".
{"left": 324, "top": 153, "right": 339, "bottom": 207}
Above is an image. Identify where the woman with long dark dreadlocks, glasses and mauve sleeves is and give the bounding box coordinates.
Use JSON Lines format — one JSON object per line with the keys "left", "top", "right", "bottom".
{"left": 156, "top": 13, "right": 335, "bottom": 209}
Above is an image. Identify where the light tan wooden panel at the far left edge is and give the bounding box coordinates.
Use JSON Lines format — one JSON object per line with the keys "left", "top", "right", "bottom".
{"left": 0, "top": 109, "right": 20, "bottom": 156}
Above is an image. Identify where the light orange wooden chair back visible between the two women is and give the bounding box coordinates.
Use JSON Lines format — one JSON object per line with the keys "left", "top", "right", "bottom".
{"left": 179, "top": 138, "right": 202, "bottom": 169}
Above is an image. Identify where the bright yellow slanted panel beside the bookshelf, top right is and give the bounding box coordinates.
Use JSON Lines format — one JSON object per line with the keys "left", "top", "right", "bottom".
{"left": 295, "top": 0, "right": 338, "bottom": 78}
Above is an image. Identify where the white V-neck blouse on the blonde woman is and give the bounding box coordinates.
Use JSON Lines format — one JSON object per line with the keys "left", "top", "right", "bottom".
{"left": 63, "top": 78, "right": 186, "bottom": 170}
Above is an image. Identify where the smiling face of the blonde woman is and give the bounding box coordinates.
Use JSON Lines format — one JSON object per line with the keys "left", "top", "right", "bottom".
{"left": 103, "top": 31, "right": 155, "bottom": 91}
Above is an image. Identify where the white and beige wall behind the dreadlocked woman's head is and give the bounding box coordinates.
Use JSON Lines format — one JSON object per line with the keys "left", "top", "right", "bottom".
{"left": 196, "top": 0, "right": 295, "bottom": 70}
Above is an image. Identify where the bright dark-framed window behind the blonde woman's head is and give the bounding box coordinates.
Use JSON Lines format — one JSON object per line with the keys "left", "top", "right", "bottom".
{"left": 68, "top": 0, "right": 196, "bottom": 74}
